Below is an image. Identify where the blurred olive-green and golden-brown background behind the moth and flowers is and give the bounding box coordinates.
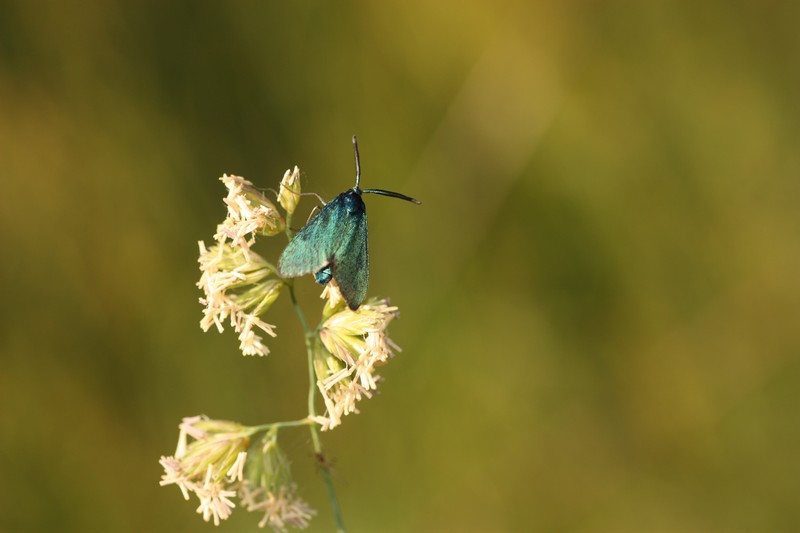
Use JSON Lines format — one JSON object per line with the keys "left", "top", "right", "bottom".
{"left": 0, "top": 0, "right": 800, "bottom": 532}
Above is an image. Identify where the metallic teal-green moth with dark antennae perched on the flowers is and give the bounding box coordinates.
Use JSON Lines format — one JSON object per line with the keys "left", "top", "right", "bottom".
{"left": 278, "top": 135, "right": 422, "bottom": 311}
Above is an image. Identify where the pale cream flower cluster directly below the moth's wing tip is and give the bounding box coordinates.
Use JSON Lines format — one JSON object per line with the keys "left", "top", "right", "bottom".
{"left": 313, "top": 282, "right": 399, "bottom": 431}
